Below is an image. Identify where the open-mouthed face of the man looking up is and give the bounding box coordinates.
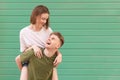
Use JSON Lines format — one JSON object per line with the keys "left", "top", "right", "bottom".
{"left": 45, "top": 34, "right": 60, "bottom": 49}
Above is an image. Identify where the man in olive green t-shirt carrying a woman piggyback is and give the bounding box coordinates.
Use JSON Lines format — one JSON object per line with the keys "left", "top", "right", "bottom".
{"left": 17, "top": 32, "right": 64, "bottom": 80}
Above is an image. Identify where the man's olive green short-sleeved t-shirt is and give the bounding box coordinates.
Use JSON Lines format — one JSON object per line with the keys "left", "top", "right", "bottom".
{"left": 20, "top": 49, "right": 56, "bottom": 80}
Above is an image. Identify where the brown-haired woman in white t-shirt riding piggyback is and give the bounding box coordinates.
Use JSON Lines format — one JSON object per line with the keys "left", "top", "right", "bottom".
{"left": 16, "top": 5, "right": 62, "bottom": 80}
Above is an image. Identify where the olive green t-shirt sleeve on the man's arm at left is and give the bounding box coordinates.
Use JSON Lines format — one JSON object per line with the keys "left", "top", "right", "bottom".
{"left": 20, "top": 49, "right": 34, "bottom": 62}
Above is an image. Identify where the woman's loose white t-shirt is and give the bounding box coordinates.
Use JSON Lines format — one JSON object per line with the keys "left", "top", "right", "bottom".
{"left": 20, "top": 25, "right": 52, "bottom": 52}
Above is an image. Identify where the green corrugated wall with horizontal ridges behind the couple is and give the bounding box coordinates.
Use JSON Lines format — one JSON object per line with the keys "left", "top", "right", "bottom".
{"left": 0, "top": 0, "right": 120, "bottom": 80}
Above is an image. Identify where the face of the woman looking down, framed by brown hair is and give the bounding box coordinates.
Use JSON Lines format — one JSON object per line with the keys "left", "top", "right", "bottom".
{"left": 36, "top": 13, "right": 49, "bottom": 26}
